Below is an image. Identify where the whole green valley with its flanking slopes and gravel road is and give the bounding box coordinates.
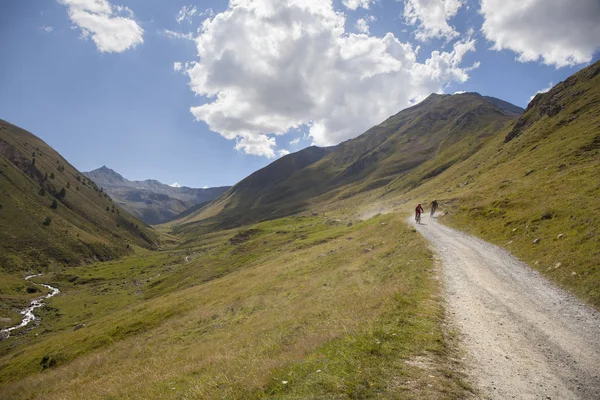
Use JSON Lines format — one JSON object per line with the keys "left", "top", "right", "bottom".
{"left": 0, "top": 58, "right": 600, "bottom": 399}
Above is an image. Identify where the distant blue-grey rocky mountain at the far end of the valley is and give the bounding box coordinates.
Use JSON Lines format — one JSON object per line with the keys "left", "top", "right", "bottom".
{"left": 84, "top": 166, "right": 229, "bottom": 224}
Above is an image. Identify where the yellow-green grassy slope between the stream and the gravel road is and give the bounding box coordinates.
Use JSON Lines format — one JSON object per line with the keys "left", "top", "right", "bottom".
{"left": 0, "top": 216, "right": 467, "bottom": 399}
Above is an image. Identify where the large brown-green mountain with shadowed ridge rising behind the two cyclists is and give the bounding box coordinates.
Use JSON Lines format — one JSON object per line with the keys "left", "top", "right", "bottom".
{"left": 175, "top": 93, "right": 523, "bottom": 229}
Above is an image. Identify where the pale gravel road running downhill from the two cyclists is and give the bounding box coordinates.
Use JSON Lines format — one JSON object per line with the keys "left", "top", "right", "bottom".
{"left": 411, "top": 216, "right": 600, "bottom": 400}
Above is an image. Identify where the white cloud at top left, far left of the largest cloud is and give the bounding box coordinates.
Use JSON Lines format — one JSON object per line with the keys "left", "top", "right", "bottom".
{"left": 58, "top": 0, "right": 144, "bottom": 53}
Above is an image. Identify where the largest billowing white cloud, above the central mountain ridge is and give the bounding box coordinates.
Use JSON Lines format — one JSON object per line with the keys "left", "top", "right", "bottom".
{"left": 184, "top": 0, "right": 475, "bottom": 157}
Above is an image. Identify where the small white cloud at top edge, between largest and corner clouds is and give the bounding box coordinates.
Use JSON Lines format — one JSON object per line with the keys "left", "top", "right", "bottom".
{"left": 404, "top": 0, "right": 463, "bottom": 41}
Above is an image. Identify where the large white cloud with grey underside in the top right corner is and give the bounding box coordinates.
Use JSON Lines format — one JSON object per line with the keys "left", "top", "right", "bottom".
{"left": 481, "top": 0, "right": 600, "bottom": 68}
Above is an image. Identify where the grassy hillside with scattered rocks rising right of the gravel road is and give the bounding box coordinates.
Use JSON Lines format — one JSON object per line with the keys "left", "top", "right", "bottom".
{"left": 394, "top": 63, "right": 600, "bottom": 307}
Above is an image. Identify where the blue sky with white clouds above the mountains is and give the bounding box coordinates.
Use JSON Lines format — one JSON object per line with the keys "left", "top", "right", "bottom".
{"left": 0, "top": 0, "right": 600, "bottom": 187}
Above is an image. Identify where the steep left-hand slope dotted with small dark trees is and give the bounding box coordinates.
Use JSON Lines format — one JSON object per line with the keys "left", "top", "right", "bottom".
{"left": 0, "top": 120, "right": 157, "bottom": 272}
